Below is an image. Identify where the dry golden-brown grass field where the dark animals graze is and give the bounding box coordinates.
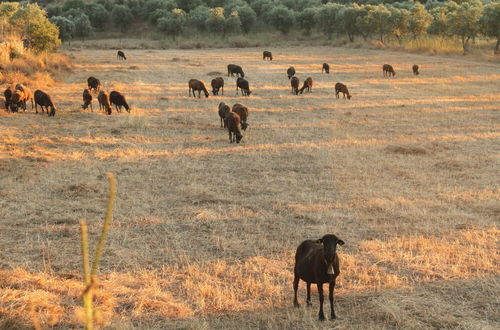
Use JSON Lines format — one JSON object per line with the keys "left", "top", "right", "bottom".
{"left": 0, "top": 47, "right": 500, "bottom": 329}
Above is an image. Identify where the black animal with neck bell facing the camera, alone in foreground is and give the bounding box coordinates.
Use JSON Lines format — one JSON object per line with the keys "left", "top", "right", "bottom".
{"left": 293, "top": 235, "right": 344, "bottom": 321}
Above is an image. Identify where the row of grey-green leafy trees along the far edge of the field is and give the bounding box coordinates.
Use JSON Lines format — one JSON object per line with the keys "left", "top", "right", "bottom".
{"left": 43, "top": 0, "right": 500, "bottom": 52}
